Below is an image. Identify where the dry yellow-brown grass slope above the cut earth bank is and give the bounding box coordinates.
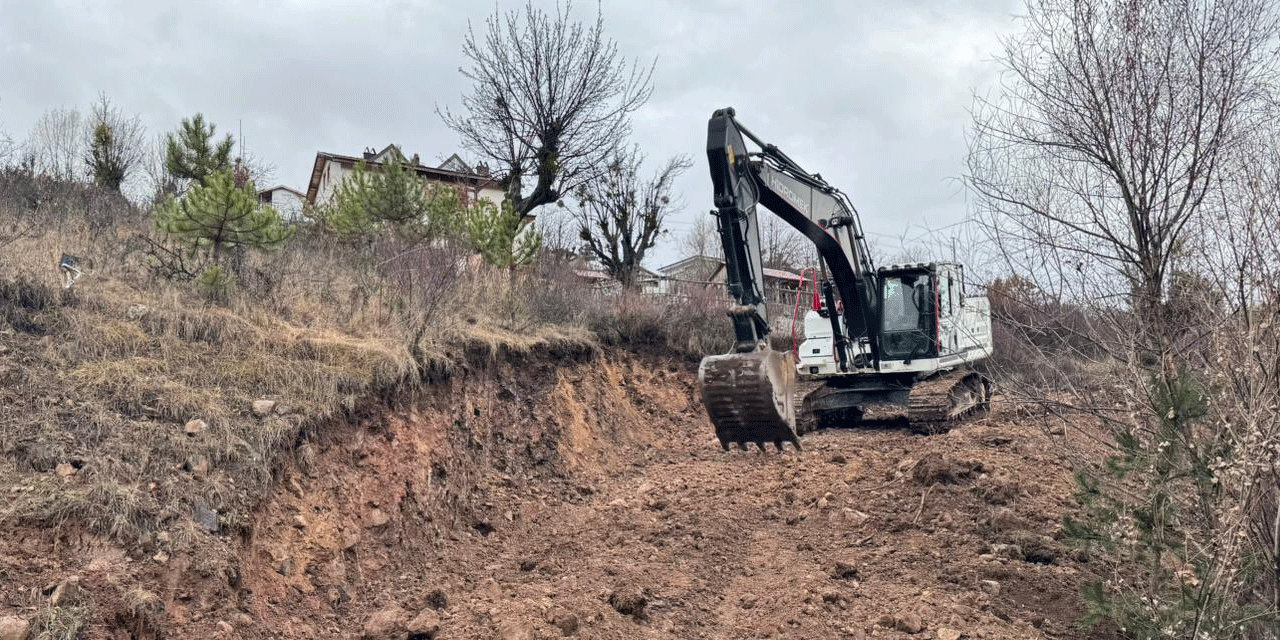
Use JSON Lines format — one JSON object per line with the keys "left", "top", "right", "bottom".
{"left": 0, "top": 175, "right": 730, "bottom": 553}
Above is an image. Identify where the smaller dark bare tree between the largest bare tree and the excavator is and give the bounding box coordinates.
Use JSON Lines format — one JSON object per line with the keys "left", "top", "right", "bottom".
{"left": 573, "top": 146, "right": 694, "bottom": 287}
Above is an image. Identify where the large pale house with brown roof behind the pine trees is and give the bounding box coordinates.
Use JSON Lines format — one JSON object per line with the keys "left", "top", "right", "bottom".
{"left": 306, "top": 145, "right": 503, "bottom": 211}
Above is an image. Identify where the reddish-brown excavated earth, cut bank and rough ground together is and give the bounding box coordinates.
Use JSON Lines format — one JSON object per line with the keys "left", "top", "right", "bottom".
{"left": 0, "top": 351, "right": 1105, "bottom": 640}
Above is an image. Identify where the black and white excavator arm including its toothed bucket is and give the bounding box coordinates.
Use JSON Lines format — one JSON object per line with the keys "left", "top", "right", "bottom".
{"left": 699, "top": 108, "right": 879, "bottom": 448}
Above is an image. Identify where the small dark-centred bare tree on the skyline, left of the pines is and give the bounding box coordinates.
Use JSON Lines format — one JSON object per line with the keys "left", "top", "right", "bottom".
{"left": 84, "top": 93, "right": 146, "bottom": 192}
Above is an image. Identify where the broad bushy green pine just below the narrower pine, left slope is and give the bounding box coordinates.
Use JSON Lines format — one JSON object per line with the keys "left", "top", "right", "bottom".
{"left": 156, "top": 170, "right": 291, "bottom": 266}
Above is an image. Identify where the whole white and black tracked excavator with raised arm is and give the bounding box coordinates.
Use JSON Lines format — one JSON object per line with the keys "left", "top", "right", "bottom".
{"left": 698, "top": 108, "right": 992, "bottom": 452}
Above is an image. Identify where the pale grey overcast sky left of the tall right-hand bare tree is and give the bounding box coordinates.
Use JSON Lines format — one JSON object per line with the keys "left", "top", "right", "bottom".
{"left": 0, "top": 0, "right": 1021, "bottom": 268}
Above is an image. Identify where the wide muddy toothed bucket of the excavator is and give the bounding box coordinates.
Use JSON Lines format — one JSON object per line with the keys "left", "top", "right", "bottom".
{"left": 698, "top": 349, "right": 800, "bottom": 451}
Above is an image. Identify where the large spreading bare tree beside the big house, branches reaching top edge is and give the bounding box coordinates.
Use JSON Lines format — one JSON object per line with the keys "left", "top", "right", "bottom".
{"left": 436, "top": 3, "right": 653, "bottom": 215}
